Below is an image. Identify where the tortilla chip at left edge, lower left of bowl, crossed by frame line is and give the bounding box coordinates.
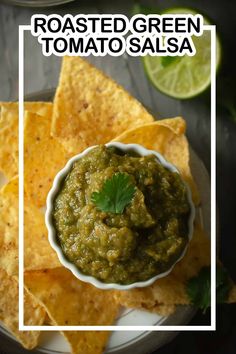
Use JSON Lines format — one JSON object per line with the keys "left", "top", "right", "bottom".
{"left": 0, "top": 177, "right": 60, "bottom": 275}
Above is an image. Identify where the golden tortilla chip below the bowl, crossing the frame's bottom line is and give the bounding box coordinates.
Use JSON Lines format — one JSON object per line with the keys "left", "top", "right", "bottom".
{"left": 25, "top": 267, "right": 119, "bottom": 354}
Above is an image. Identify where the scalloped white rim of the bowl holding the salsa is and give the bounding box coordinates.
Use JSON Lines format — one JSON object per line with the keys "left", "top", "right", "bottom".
{"left": 45, "top": 142, "right": 195, "bottom": 290}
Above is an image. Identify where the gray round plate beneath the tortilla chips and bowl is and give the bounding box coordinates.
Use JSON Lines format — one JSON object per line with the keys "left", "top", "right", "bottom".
{"left": 0, "top": 89, "right": 210, "bottom": 354}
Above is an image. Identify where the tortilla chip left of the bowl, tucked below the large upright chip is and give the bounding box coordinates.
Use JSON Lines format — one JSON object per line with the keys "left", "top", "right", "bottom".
{"left": 24, "top": 111, "right": 68, "bottom": 207}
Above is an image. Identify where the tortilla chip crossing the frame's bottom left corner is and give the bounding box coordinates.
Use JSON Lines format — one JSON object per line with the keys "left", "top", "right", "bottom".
{"left": 0, "top": 268, "right": 46, "bottom": 349}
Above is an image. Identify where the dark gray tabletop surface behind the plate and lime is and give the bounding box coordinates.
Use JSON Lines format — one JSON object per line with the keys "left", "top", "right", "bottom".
{"left": 0, "top": 0, "right": 236, "bottom": 354}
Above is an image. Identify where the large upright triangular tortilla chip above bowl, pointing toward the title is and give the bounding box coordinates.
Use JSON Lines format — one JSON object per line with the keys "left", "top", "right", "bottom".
{"left": 52, "top": 57, "right": 154, "bottom": 154}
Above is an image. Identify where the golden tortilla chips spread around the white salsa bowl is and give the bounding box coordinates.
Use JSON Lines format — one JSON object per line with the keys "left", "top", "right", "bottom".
{"left": 0, "top": 57, "right": 236, "bottom": 354}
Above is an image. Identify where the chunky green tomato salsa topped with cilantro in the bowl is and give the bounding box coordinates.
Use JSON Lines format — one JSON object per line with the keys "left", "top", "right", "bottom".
{"left": 53, "top": 145, "right": 190, "bottom": 284}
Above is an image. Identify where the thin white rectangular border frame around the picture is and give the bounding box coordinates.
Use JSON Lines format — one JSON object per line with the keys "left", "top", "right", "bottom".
{"left": 19, "top": 25, "right": 216, "bottom": 331}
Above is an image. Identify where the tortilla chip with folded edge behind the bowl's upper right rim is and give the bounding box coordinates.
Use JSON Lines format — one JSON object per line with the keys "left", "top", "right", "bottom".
{"left": 113, "top": 117, "right": 200, "bottom": 205}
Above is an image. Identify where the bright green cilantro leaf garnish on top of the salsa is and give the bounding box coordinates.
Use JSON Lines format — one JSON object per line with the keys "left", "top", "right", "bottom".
{"left": 91, "top": 172, "right": 135, "bottom": 214}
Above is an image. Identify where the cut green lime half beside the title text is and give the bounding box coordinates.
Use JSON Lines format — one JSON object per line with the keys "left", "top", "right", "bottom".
{"left": 143, "top": 8, "right": 221, "bottom": 99}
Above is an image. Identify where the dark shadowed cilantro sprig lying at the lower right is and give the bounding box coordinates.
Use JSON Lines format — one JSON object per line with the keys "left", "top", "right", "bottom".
{"left": 186, "top": 265, "right": 231, "bottom": 313}
